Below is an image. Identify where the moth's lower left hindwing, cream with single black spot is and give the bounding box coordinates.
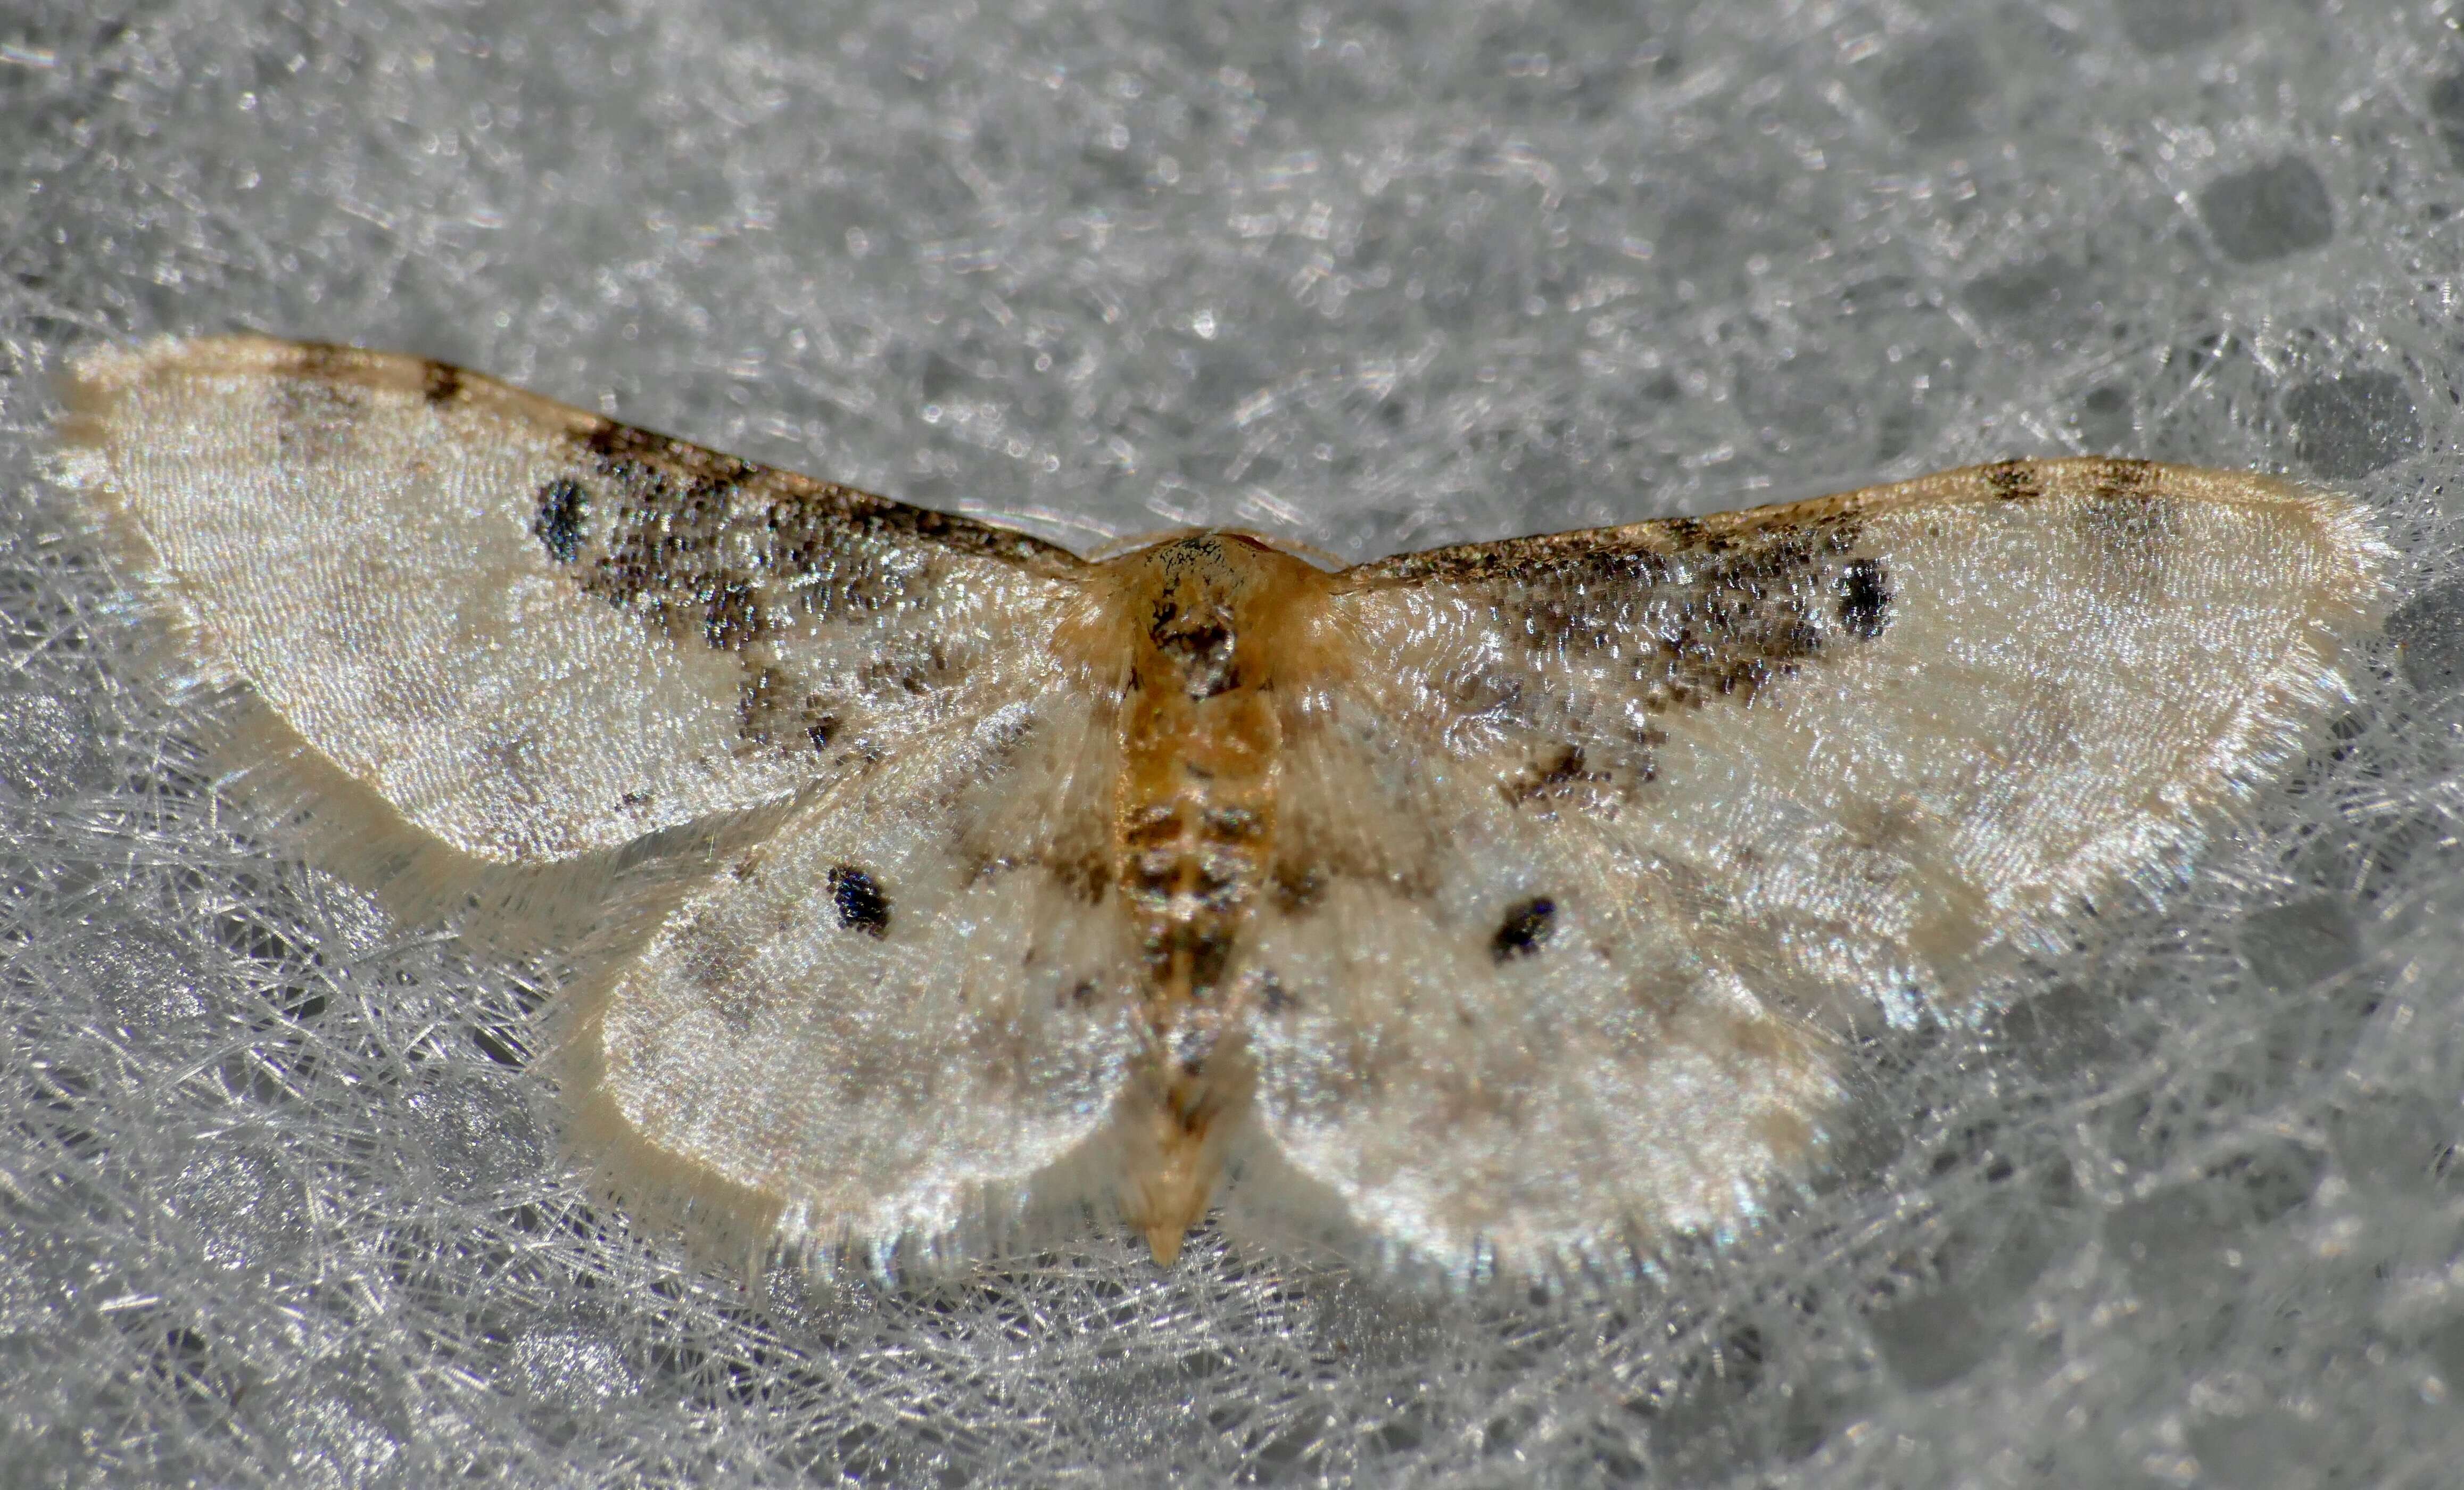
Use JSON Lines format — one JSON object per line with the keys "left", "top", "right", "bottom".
{"left": 559, "top": 694, "right": 1136, "bottom": 1271}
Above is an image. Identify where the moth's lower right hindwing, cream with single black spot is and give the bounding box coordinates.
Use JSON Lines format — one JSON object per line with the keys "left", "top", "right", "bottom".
{"left": 1244, "top": 694, "right": 1841, "bottom": 1278}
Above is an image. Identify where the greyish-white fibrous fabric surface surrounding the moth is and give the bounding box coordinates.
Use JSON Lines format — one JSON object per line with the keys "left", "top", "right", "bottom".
{"left": 0, "top": 0, "right": 2464, "bottom": 1487}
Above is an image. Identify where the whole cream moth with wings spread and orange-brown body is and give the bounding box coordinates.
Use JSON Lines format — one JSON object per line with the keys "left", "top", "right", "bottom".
{"left": 64, "top": 337, "right": 2385, "bottom": 1278}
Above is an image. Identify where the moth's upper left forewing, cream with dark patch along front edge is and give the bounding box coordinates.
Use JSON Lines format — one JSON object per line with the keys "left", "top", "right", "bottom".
{"left": 50, "top": 337, "right": 1082, "bottom": 864}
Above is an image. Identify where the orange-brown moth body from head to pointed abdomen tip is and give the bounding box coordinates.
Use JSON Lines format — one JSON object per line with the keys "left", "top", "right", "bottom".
{"left": 1104, "top": 532, "right": 1330, "bottom": 1256}
